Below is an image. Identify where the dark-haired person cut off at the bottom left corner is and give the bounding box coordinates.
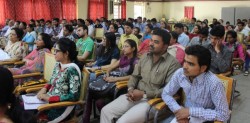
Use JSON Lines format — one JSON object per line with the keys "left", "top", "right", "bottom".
{"left": 0, "top": 66, "right": 15, "bottom": 123}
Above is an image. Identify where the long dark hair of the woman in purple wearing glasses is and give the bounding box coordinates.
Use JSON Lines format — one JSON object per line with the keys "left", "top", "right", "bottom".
{"left": 125, "top": 39, "right": 138, "bottom": 75}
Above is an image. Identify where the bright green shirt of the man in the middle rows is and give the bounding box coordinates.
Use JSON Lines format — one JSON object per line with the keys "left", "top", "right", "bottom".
{"left": 76, "top": 37, "right": 94, "bottom": 59}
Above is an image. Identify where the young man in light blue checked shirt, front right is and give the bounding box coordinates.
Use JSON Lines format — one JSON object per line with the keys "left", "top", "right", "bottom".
{"left": 162, "top": 45, "right": 229, "bottom": 123}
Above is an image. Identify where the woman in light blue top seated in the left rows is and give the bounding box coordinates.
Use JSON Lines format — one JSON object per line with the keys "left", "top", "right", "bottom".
{"left": 22, "top": 24, "right": 36, "bottom": 52}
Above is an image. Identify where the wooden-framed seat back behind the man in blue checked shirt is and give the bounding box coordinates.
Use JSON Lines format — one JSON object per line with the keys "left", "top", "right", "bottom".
{"left": 217, "top": 74, "right": 236, "bottom": 110}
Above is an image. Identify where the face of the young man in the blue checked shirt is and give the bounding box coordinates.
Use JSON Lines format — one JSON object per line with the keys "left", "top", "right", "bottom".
{"left": 183, "top": 54, "right": 207, "bottom": 78}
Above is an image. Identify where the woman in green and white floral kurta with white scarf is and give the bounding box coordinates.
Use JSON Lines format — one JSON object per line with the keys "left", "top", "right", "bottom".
{"left": 37, "top": 38, "right": 82, "bottom": 121}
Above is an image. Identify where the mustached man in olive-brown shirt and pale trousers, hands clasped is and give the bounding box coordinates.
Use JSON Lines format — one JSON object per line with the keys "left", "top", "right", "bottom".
{"left": 100, "top": 29, "right": 180, "bottom": 123}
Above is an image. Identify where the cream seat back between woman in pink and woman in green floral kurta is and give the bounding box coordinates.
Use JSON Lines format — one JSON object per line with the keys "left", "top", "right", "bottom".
{"left": 43, "top": 53, "right": 56, "bottom": 82}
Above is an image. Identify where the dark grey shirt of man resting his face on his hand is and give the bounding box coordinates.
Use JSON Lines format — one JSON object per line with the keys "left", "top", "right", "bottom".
{"left": 207, "top": 44, "right": 232, "bottom": 74}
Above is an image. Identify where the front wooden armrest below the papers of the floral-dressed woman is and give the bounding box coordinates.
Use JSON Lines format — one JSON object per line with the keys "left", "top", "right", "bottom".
{"left": 37, "top": 101, "right": 85, "bottom": 111}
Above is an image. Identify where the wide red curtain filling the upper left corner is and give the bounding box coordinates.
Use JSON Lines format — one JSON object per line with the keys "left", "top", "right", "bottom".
{"left": 0, "top": 0, "right": 76, "bottom": 26}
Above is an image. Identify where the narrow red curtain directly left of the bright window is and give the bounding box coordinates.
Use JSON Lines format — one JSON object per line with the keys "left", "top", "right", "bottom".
{"left": 88, "top": 0, "right": 108, "bottom": 20}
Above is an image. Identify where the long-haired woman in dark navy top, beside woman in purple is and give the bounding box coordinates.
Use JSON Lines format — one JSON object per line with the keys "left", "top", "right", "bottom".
{"left": 86, "top": 32, "right": 120, "bottom": 74}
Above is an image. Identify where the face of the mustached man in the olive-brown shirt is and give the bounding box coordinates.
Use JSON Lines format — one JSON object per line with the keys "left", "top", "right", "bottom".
{"left": 149, "top": 35, "right": 168, "bottom": 55}
